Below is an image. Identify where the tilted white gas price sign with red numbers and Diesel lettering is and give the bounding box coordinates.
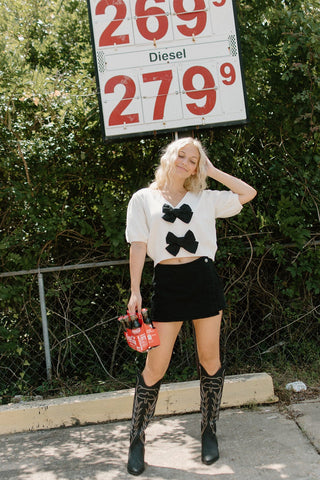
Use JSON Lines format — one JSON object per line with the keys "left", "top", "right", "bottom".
{"left": 88, "top": 0, "right": 247, "bottom": 139}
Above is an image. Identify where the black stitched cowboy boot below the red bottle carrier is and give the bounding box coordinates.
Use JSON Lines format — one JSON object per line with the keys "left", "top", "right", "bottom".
{"left": 127, "top": 375, "right": 161, "bottom": 475}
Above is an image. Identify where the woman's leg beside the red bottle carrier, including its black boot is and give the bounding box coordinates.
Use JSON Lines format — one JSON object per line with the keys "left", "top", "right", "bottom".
{"left": 127, "top": 322, "right": 182, "bottom": 475}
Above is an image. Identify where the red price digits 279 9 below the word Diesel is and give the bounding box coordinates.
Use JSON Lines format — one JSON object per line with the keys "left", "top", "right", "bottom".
{"left": 103, "top": 61, "right": 238, "bottom": 127}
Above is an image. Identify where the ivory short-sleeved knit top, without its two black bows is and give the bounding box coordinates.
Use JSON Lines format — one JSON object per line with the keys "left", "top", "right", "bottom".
{"left": 126, "top": 188, "right": 242, "bottom": 265}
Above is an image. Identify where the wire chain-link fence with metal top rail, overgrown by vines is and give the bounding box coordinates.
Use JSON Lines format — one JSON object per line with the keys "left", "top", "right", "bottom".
{"left": 0, "top": 246, "right": 320, "bottom": 403}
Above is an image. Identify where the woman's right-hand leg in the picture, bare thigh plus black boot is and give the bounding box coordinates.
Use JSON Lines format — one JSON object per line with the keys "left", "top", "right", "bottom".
{"left": 194, "top": 312, "right": 224, "bottom": 465}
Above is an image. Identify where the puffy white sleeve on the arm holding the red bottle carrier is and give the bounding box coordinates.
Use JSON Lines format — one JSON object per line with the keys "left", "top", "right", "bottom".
{"left": 126, "top": 191, "right": 149, "bottom": 243}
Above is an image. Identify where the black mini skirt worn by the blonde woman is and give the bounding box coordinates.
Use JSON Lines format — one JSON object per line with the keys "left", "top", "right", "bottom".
{"left": 151, "top": 257, "right": 226, "bottom": 322}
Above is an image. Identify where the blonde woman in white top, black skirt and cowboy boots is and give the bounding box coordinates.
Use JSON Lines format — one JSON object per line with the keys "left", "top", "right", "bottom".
{"left": 126, "top": 137, "right": 256, "bottom": 475}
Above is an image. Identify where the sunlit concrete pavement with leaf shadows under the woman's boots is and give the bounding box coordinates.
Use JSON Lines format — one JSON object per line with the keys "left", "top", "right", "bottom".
{"left": 0, "top": 398, "right": 320, "bottom": 480}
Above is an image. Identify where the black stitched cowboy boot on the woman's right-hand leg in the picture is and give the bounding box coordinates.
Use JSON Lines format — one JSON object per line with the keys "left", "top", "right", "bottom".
{"left": 200, "top": 365, "right": 224, "bottom": 465}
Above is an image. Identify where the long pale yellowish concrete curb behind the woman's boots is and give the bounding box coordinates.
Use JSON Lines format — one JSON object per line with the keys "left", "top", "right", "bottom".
{"left": 0, "top": 373, "right": 278, "bottom": 435}
